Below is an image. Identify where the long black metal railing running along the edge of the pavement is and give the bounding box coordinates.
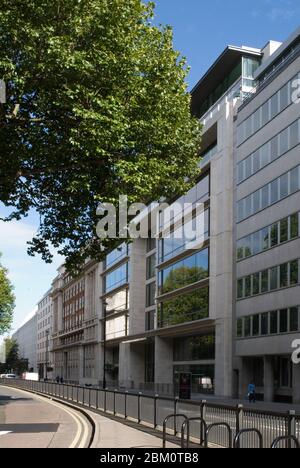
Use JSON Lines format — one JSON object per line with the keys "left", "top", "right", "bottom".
{"left": 0, "top": 379, "right": 300, "bottom": 448}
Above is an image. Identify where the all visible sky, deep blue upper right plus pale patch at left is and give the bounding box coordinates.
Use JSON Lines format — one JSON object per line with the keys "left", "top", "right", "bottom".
{"left": 0, "top": 0, "right": 300, "bottom": 329}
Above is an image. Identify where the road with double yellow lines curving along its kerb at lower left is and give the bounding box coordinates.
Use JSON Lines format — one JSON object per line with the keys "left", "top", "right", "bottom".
{"left": 0, "top": 385, "right": 91, "bottom": 448}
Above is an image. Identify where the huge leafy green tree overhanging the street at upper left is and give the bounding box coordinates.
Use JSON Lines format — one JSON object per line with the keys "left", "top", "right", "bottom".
{"left": 0, "top": 0, "right": 201, "bottom": 268}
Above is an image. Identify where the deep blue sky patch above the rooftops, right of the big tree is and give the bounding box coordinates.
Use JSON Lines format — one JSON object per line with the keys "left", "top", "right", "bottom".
{"left": 155, "top": 0, "right": 300, "bottom": 88}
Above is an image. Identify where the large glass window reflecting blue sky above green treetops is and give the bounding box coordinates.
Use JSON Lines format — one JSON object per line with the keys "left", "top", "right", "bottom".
{"left": 159, "top": 249, "right": 209, "bottom": 294}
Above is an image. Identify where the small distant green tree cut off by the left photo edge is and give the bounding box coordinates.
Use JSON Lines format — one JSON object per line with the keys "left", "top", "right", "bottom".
{"left": 0, "top": 254, "right": 15, "bottom": 335}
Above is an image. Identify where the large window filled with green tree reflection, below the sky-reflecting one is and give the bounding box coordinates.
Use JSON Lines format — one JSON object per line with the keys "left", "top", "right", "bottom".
{"left": 158, "top": 288, "right": 209, "bottom": 328}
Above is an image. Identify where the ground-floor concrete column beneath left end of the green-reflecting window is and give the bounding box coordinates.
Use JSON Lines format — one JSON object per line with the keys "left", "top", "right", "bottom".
{"left": 155, "top": 336, "right": 173, "bottom": 384}
